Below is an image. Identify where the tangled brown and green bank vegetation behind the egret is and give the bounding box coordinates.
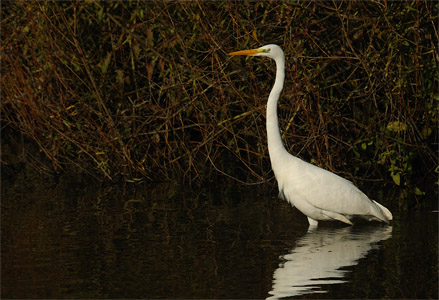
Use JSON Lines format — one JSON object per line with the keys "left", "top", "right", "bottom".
{"left": 1, "top": 0, "right": 439, "bottom": 206}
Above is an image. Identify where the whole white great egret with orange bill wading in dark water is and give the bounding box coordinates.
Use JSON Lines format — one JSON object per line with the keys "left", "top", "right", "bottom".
{"left": 229, "top": 44, "right": 392, "bottom": 227}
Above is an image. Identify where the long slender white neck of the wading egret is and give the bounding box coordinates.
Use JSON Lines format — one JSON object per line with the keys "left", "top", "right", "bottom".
{"left": 267, "top": 55, "right": 288, "bottom": 173}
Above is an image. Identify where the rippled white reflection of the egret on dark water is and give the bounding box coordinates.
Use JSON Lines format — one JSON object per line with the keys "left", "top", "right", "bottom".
{"left": 267, "top": 226, "right": 392, "bottom": 299}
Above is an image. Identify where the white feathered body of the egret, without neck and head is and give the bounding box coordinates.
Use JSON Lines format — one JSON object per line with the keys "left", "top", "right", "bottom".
{"left": 273, "top": 155, "right": 392, "bottom": 223}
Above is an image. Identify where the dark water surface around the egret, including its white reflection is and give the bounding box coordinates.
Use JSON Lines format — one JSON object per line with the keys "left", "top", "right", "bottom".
{"left": 1, "top": 172, "right": 438, "bottom": 299}
